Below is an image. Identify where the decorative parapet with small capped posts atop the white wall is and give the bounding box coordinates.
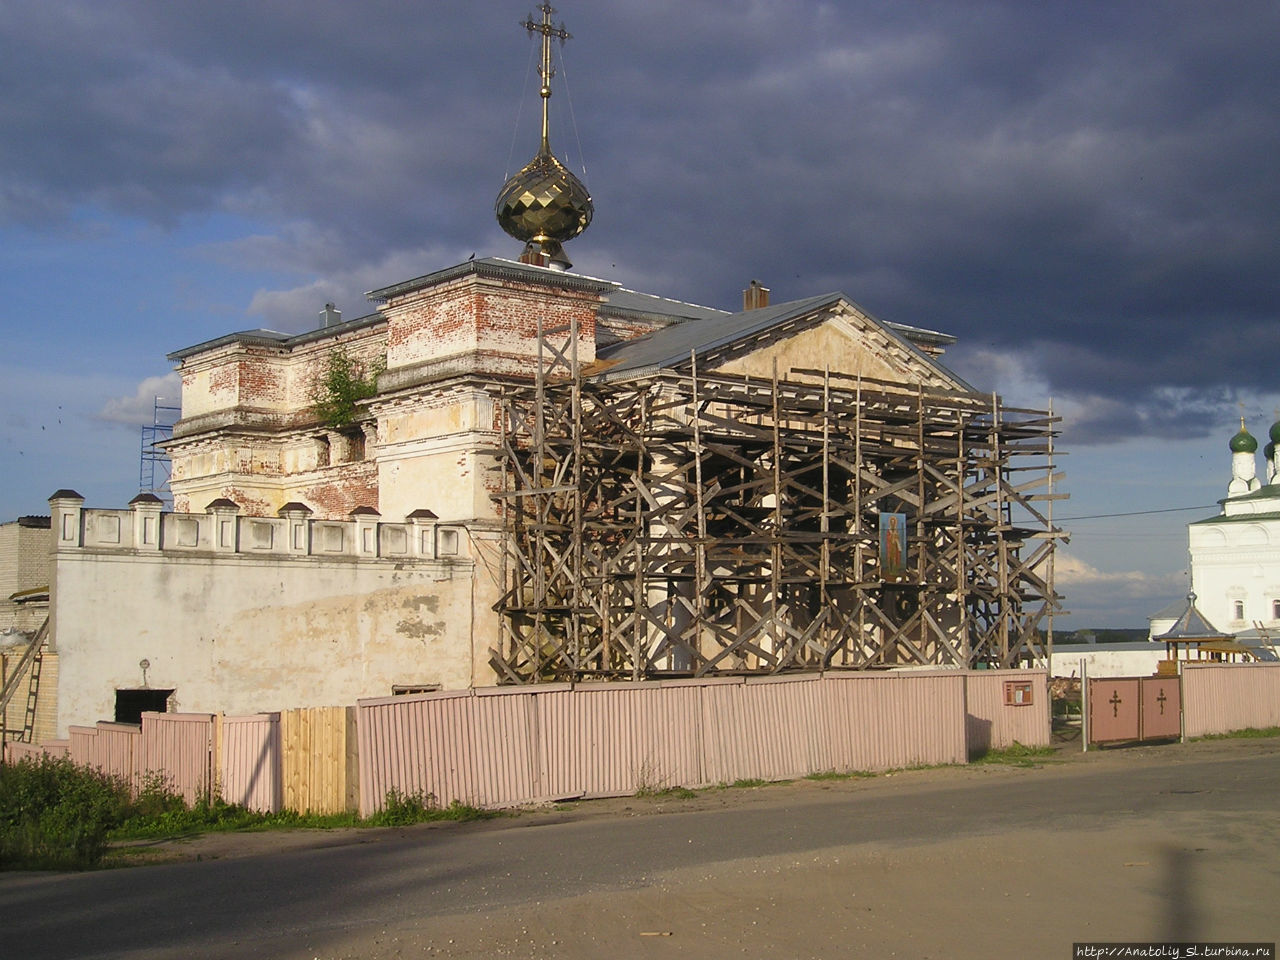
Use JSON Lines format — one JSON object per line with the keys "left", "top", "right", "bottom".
{"left": 49, "top": 490, "right": 468, "bottom": 562}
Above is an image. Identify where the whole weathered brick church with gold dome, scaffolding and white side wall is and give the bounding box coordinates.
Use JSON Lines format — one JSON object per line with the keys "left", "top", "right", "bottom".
{"left": 15, "top": 5, "right": 1060, "bottom": 730}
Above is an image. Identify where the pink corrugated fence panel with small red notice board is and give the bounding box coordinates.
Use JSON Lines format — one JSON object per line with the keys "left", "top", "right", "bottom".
{"left": 964, "top": 669, "right": 1050, "bottom": 756}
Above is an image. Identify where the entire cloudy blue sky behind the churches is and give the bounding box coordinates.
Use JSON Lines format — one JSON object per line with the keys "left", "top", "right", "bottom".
{"left": 0, "top": 0, "right": 1280, "bottom": 626}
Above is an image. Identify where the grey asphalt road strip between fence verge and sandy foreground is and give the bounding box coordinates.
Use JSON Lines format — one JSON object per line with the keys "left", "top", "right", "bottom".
{"left": 0, "top": 741, "right": 1280, "bottom": 960}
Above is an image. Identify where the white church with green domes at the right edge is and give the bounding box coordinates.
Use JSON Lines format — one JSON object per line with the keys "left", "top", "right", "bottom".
{"left": 1151, "top": 417, "right": 1280, "bottom": 643}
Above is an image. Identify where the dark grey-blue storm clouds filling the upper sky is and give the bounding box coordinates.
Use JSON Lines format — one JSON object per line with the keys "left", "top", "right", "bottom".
{"left": 0, "top": 0, "right": 1280, "bottom": 440}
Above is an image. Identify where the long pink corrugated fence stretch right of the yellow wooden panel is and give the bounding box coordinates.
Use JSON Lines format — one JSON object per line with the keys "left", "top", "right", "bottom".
{"left": 358, "top": 671, "right": 965, "bottom": 815}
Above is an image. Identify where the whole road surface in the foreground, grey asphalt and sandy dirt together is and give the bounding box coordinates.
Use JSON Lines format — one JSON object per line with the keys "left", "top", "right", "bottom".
{"left": 0, "top": 740, "right": 1280, "bottom": 960}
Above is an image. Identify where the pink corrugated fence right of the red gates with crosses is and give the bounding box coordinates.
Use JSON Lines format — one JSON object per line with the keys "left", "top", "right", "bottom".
{"left": 1183, "top": 663, "right": 1280, "bottom": 737}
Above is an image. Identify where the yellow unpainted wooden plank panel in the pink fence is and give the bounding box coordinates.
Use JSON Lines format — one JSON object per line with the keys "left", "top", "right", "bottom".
{"left": 280, "top": 707, "right": 360, "bottom": 813}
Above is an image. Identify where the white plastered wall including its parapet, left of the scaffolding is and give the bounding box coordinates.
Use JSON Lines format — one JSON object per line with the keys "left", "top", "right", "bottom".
{"left": 43, "top": 498, "right": 499, "bottom": 736}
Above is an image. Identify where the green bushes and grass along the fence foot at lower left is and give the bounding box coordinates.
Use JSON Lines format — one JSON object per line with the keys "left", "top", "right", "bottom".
{"left": 0, "top": 756, "right": 500, "bottom": 870}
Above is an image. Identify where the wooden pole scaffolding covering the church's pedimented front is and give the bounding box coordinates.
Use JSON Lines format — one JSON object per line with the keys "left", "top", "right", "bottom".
{"left": 492, "top": 320, "right": 1062, "bottom": 684}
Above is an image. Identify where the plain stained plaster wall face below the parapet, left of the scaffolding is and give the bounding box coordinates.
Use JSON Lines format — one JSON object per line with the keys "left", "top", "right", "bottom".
{"left": 55, "top": 550, "right": 483, "bottom": 736}
